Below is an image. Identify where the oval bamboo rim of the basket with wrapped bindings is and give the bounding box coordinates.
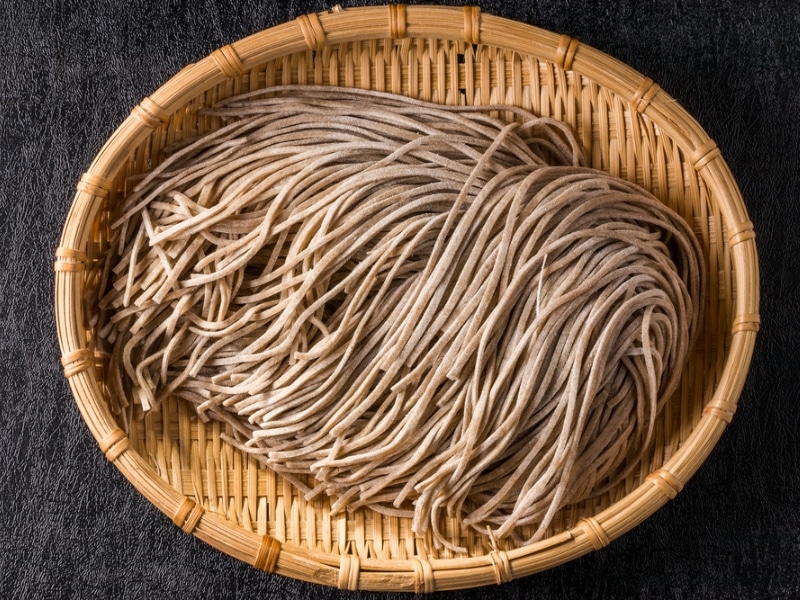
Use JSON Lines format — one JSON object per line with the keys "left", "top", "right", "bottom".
{"left": 55, "top": 5, "right": 759, "bottom": 592}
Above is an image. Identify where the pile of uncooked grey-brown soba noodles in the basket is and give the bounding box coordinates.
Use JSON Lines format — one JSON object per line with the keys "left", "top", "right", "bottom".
{"left": 102, "top": 87, "right": 703, "bottom": 549}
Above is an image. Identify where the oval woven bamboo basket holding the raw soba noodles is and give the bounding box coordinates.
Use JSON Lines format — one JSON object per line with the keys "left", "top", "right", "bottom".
{"left": 55, "top": 5, "right": 759, "bottom": 592}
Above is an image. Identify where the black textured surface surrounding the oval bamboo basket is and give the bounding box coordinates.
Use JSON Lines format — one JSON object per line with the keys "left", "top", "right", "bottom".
{"left": 0, "top": 0, "right": 800, "bottom": 599}
